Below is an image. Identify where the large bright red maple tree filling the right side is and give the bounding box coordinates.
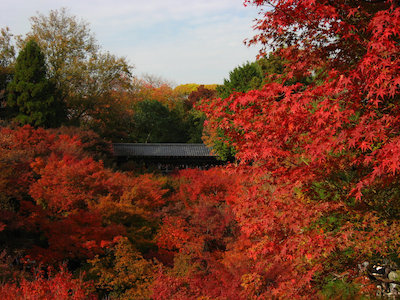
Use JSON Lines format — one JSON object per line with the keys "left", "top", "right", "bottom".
{"left": 195, "top": 0, "right": 400, "bottom": 298}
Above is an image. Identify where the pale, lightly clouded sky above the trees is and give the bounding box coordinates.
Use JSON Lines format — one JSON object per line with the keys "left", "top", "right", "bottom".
{"left": 0, "top": 0, "right": 259, "bottom": 85}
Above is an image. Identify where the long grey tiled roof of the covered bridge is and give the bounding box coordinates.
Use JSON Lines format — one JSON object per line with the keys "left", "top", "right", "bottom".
{"left": 113, "top": 143, "right": 214, "bottom": 157}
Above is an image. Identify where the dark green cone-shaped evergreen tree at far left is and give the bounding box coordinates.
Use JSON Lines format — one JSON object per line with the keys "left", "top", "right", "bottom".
{"left": 7, "top": 40, "right": 64, "bottom": 127}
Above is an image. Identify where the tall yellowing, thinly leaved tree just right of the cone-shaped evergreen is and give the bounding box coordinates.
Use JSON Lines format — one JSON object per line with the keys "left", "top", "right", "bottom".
{"left": 21, "top": 8, "right": 132, "bottom": 127}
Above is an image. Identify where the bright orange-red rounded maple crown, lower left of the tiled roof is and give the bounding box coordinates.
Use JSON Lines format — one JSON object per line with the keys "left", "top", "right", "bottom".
{"left": 30, "top": 155, "right": 126, "bottom": 213}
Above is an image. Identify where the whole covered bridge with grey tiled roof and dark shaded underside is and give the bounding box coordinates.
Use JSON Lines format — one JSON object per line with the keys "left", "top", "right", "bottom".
{"left": 113, "top": 143, "right": 223, "bottom": 173}
